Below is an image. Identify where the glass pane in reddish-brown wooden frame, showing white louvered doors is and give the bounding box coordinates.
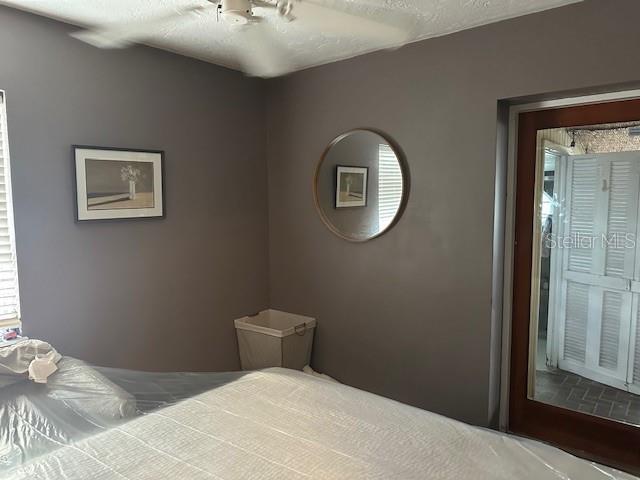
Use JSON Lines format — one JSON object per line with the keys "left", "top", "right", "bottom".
{"left": 529, "top": 122, "right": 640, "bottom": 426}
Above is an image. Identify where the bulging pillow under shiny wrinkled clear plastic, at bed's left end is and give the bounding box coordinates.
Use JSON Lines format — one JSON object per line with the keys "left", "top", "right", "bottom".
{"left": 0, "top": 357, "right": 136, "bottom": 466}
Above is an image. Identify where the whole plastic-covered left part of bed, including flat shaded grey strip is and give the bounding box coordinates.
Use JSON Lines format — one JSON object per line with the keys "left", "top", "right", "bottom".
{"left": 0, "top": 357, "right": 243, "bottom": 468}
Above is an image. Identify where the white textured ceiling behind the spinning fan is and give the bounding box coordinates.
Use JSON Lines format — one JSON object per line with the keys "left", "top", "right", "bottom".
{"left": 0, "top": 0, "right": 582, "bottom": 75}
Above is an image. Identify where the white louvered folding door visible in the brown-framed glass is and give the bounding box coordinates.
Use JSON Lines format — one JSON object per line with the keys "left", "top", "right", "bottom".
{"left": 558, "top": 152, "right": 640, "bottom": 389}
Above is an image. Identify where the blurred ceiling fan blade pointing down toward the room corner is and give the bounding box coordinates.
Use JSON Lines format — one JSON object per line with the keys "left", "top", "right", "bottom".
{"left": 237, "top": 21, "right": 294, "bottom": 78}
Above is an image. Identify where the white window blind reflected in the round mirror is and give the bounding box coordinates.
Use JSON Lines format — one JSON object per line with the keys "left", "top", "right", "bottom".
{"left": 378, "top": 144, "right": 402, "bottom": 231}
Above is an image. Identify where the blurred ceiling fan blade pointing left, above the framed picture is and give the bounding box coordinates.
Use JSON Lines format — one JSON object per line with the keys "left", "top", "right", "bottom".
{"left": 70, "top": 3, "right": 217, "bottom": 48}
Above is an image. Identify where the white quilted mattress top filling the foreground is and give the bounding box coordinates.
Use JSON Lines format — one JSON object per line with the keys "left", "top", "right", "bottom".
{"left": 2, "top": 369, "right": 633, "bottom": 480}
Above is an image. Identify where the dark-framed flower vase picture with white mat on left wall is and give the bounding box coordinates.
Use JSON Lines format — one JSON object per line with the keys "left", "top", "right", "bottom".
{"left": 72, "top": 145, "right": 165, "bottom": 222}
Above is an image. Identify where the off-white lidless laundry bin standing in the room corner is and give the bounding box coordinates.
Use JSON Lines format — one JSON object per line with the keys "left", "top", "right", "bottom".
{"left": 235, "top": 310, "right": 316, "bottom": 370}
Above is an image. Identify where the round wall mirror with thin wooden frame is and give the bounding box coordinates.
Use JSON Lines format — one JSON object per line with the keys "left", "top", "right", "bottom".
{"left": 314, "top": 129, "right": 409, "bottom": 242}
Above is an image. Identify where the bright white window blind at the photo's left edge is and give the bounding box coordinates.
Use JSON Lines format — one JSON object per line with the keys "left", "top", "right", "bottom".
{"left": 0, "top": 91, "right": 20, "bottom": 327}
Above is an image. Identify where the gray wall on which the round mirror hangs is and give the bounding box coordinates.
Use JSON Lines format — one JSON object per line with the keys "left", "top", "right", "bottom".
{"left": 267, "top": 0, "right": 640, "bottom": 425}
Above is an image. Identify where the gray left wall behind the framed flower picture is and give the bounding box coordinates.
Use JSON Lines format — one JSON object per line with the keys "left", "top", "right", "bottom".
{"left": 0, "top": 7, "right": 268, "bottom": 370}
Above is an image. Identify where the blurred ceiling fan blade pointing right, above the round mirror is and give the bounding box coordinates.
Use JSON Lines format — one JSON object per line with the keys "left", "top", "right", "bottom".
{"left": 293, "top": 0, "right": 417, "bottom": 48}
